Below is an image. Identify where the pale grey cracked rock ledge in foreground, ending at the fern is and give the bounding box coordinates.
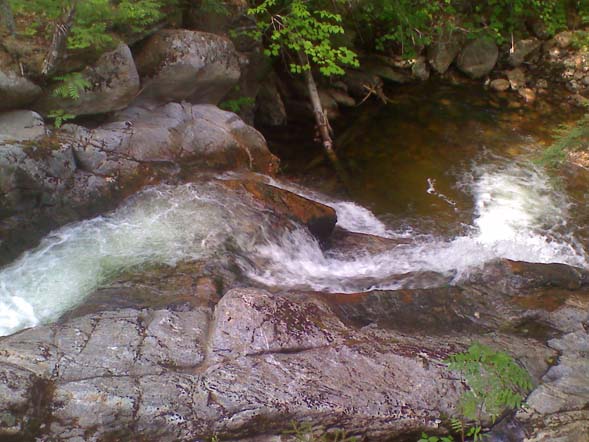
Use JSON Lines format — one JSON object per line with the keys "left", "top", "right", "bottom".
{"left": 0, "top": 289, "right": 465, "bottom": 441}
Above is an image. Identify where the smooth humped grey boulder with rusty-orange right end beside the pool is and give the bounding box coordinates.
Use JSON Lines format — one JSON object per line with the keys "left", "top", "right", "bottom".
{"left": 101, "top": 103, "right": 278, "bottom": 173}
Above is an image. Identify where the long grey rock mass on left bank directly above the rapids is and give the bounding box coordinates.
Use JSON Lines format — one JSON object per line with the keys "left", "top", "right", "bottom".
{"left": 0, "top": 103, "right": 278, "bottom": 224}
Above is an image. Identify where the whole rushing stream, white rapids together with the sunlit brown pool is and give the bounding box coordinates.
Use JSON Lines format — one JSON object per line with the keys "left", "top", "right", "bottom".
{"left": 0, "top": 83, "right": 589, "bottom": 335}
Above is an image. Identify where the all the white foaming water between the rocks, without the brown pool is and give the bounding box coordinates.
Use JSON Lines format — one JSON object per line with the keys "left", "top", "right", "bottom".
{"left": 0, "top": 164, "right": 588, "bottom": 335}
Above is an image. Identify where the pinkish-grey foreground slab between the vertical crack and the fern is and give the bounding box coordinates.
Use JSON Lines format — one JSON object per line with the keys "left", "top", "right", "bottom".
{"left": 205, "top": 290, "right": 468, "bottom": 440}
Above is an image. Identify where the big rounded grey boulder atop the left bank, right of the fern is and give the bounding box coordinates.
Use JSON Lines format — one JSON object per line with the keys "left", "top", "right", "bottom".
{"left": 135, "top": 29, "right": 240, "bottom": 104}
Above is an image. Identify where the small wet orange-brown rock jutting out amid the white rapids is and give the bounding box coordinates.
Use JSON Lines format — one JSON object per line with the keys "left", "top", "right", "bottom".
{"left": 222, "top": 180, "right": 337, "bottom": 241}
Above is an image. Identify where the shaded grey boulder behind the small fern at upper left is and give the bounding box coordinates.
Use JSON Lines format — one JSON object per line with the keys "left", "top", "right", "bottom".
{"left": 35, "top": 44, "right": 139, "bottom": 115}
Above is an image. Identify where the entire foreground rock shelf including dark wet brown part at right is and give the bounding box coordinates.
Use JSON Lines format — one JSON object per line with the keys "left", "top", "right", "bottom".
{"left": 0, "top": 261, "right": 589, "bottom": 441}
